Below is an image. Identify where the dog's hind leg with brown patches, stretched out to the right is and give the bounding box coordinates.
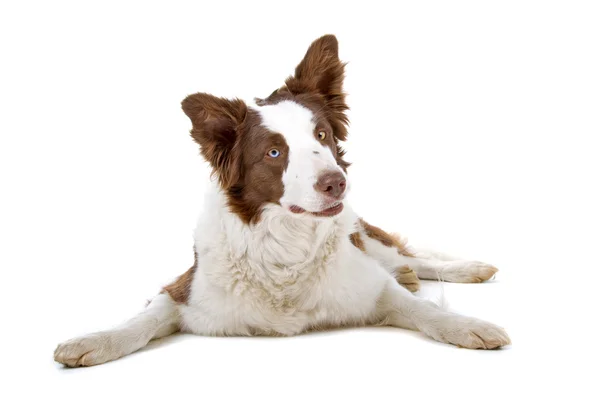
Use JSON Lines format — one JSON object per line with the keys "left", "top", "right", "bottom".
{"left": 350, "top": 220, "right": 498, "bottom": 284}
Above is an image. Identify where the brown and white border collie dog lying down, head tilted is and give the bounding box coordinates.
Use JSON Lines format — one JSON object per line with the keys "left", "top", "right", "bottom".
{"left": 54, "top": 35, "right": 510, "bottom": 367}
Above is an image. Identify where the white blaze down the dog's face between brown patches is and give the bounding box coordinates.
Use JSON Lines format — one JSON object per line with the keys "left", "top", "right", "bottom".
{"left": 256, "top": 100, "right": 343, "bottom": 211}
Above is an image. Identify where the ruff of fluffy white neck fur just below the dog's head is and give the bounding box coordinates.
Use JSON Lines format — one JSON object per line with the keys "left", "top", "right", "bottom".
{"left": 195, "top": 183, "right": 355, "bottom": 271}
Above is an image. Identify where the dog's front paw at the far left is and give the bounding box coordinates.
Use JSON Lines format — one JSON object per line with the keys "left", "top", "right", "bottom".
{"left": 54, "top": 332, "right": 121, "bottom": 367}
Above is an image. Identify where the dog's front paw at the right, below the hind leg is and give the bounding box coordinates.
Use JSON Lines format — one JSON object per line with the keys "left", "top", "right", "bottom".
{"left": 427, "top": 315, "right": 510, "bottom": 350}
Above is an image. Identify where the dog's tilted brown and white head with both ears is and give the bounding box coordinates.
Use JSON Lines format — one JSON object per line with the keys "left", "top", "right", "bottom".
{"left": 182, "top": 35, "right": 349, "bottom": 223}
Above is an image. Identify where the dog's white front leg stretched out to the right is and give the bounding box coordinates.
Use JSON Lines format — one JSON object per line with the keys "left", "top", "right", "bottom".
{"left": 378, "top": 279, "right": 510, "bottom": 349}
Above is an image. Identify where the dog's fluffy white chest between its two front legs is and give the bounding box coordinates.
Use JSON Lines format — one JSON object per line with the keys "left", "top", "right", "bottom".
{"left": 181, "top": 195, "right": 381, "bottom": 335}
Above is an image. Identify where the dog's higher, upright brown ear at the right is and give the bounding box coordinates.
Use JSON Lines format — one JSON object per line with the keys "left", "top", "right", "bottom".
{"left": 284, "top": 35, "right": 348, "bottom": 140}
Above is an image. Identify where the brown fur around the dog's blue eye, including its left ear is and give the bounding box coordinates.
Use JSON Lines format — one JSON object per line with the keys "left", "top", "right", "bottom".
{"left": 182, "top": 93, "right": 289, "bottom": 224}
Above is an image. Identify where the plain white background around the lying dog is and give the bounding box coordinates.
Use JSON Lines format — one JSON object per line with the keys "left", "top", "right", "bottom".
{"left": 0, "top": 1, "right": 600, "bottom": 399}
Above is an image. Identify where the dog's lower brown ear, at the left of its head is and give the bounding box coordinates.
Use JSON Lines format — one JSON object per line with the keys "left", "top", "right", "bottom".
{"left": 181, "top": 93, "right": 248, "bottom": 189}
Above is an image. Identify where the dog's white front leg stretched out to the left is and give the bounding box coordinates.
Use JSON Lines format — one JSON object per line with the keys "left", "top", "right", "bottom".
{"left": 54, "top": 293, "right": 179, "bottom": 367}
